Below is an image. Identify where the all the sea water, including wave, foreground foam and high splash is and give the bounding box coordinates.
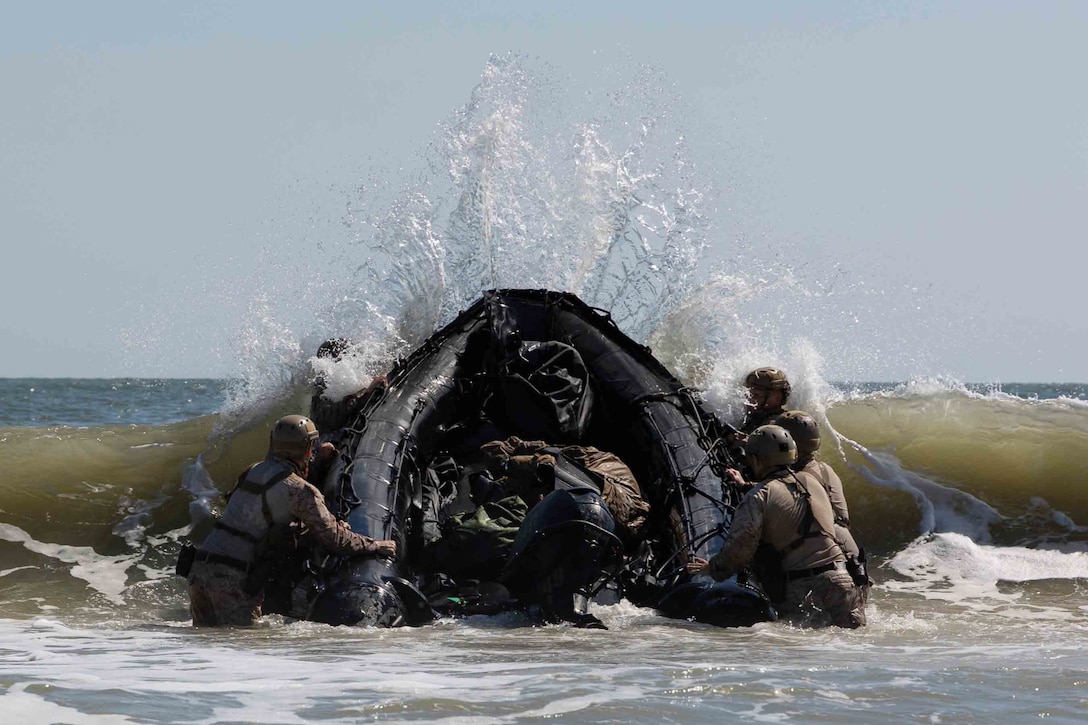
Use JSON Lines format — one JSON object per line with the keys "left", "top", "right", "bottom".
{"left": 0, "top": 57, "right": 1088, "bottom": 725}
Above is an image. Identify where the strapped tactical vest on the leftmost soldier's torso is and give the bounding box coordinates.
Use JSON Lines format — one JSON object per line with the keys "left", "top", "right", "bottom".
{"left": 197, "top": 457, "right": 295, "bottom": 569}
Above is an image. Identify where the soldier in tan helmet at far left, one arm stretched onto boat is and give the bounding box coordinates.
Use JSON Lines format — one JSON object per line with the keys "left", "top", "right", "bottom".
{"left": 180, "top": 415, "right": 397, "bottom": 626}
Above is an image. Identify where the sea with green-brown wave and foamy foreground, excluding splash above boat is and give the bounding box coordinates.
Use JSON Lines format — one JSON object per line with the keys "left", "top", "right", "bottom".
{"left": 0, "top": 380, "right": 1088, "bottom": 723}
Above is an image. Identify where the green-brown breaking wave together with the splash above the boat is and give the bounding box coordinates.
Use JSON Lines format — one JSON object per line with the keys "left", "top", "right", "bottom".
{"left": 0, "top": 57, "right": 1088, "bottom": 617}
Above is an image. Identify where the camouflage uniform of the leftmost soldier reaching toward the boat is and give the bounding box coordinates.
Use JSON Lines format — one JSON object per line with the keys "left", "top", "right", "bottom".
{"left": 188, "top": 456, "right": 378, "bottom": 626}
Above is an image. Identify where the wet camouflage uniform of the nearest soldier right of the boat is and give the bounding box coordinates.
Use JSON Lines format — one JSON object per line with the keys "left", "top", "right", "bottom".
{"left": 709, "top": 467, "right": 865, "bottom": 628}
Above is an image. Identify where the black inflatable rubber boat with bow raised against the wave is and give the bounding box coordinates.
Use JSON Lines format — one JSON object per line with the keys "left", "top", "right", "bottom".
{"left": 267, "top": 290, "right": 775, "bottom": 626}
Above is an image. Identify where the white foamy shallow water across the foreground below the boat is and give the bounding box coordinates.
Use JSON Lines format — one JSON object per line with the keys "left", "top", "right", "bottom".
{"left": 0, "top": 594, "right": 1084, "bottom": 723}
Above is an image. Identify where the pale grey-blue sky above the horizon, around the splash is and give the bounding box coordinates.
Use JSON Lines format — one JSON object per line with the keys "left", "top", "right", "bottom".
{"left": 0, "top": 0, "right": 1088, "bottom": 382}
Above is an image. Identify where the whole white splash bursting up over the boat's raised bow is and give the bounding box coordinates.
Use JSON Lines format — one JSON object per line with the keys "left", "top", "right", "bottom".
{"left": 218, "top": 54, "right": 926, "bottom": 455}
